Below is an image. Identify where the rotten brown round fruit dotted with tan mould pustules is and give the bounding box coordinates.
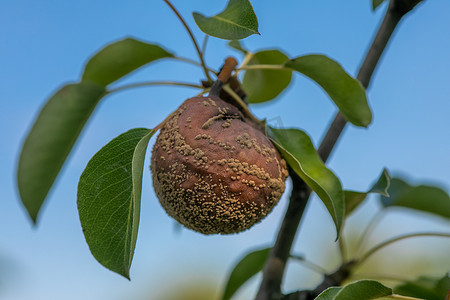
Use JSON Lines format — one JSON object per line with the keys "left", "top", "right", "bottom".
{"left": 151, "top": 96, "right": 288, "bottom": 234}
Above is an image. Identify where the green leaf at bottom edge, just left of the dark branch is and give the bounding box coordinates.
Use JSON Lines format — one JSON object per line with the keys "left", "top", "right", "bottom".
{"left": 222, "top": 248, "right": 271, "bottom": 300}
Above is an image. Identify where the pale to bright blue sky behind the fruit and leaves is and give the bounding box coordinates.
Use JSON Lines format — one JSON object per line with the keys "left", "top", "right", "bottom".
{"left": 0, "top": 0, "right": 450, "bottom": 300}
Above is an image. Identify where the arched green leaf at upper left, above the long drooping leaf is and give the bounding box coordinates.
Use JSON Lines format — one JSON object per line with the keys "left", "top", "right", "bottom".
{"left": 82, "top": 38, "right": 174, "bottom": 86}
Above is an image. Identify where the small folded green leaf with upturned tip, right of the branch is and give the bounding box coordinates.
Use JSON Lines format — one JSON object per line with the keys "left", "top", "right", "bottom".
{"left": 344, "top": 169, "right": 391, "bottom": 216}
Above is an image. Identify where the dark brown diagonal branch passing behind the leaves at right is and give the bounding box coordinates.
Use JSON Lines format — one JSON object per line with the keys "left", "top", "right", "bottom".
{"left": 256, "top": 0, "right": 422, "bottom": 300}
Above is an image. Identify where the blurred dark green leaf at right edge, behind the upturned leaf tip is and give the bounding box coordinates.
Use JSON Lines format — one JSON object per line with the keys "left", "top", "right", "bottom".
{"left": 380, "top": 178, "right": 450, "bottom": 218}
